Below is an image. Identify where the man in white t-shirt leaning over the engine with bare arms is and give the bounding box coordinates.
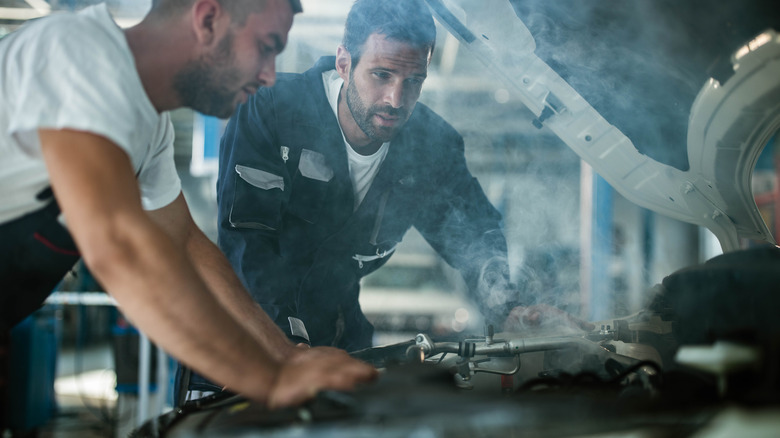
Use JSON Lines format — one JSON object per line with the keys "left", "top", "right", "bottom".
{"left": 0, "top": 0, "right": 376, "bottom": 420}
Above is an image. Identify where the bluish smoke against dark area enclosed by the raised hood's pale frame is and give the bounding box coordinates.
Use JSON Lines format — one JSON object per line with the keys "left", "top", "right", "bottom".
{"left": 512, "top": 0, "right": 780, "bottom": 170}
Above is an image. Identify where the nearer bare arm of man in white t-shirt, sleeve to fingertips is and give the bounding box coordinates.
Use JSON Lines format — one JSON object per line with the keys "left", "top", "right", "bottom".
{"left": 39, "top": 130, "right": 375, "bottom": 405}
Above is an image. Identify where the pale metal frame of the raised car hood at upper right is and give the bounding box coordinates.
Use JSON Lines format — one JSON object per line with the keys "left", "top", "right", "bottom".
{"left": 426, "top": 0, "right": 780, "bottom": 252}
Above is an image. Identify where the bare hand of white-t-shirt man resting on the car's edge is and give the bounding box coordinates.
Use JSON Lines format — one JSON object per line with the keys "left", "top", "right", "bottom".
{"left": 267, "top": 347, "right": 378, "bottom": 409}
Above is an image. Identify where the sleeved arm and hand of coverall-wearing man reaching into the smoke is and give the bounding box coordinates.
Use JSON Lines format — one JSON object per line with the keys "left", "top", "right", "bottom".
{"left": 415, "top": 132, "right": 593, "bottom": 331}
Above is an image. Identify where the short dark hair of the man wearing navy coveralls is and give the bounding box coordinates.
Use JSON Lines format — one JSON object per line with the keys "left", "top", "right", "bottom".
{"left": 342, "top": 0, "right": 436, "bottom": 67}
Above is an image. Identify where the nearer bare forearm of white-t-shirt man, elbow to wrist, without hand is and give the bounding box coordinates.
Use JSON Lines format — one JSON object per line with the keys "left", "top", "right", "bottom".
{"left": 82, "top": 206, "right": 279, "bottom": 401}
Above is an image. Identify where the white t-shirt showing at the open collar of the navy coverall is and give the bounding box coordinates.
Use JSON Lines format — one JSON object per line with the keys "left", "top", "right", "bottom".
{"left": 322, "top": 70, "right": 390, "bottom": 210}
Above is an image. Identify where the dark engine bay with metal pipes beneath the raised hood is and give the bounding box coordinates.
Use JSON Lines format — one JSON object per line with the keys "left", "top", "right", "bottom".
{"left": 134, "top": 247, "right": 780, "bottom": 437}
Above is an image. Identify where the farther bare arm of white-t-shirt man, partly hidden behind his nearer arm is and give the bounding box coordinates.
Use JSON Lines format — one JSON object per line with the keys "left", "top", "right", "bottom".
{"left": 149, "top": 195, "right": 297, "bottom": 361}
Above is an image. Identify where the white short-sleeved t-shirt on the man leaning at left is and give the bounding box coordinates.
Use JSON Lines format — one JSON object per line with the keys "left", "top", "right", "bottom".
{"left": 0, "top": 4, "right": 181, "bottom": 223}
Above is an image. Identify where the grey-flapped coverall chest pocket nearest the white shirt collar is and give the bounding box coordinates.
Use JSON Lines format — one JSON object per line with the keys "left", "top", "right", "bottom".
{"left": 287, "top": 149, "right": 333, "bottom": 223}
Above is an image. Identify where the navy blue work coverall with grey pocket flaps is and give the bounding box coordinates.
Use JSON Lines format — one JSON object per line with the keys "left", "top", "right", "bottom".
{"left": 217, "top": 57, "right": 516, "bottom": 351}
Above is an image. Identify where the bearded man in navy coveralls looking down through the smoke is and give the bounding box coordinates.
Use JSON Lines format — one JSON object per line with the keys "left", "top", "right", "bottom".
{"left": 218, "top": 0, "right": 592, "bottom": 358}
